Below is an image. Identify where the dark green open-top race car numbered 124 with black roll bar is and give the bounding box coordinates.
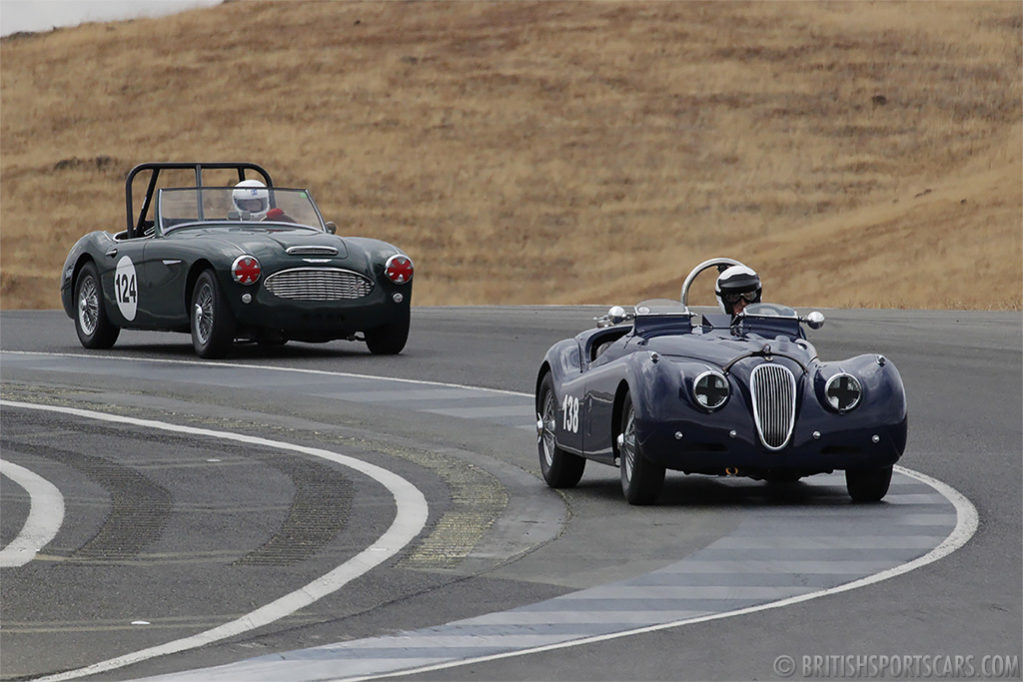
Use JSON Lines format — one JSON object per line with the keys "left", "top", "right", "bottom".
{"left": 60, "top": 163, "right": 412, "bottom": 358}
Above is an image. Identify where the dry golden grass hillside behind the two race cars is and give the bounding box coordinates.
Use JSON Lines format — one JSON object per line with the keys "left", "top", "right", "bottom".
{"left": 0, "top": 0, "right": 1023, "bottom": 310}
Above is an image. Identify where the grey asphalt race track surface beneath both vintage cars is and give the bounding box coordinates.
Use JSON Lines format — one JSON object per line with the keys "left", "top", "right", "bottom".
{"left": 0, "top": 308, "right": 1023, "bottom": 680}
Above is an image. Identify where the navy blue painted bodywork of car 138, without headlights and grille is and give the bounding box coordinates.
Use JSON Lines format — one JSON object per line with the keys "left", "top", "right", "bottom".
{"left": 536, "top": 304, "right": 906, "bottom": 487}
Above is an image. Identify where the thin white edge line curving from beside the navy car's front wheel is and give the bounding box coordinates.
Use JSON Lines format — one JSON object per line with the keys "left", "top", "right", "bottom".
{"left": 330, "top": 465, "right": 978, "bottom": 682}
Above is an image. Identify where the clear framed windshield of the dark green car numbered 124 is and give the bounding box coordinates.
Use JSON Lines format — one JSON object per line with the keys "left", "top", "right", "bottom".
{"left": 157, "top": 187, "right": 323, "bottom": 232}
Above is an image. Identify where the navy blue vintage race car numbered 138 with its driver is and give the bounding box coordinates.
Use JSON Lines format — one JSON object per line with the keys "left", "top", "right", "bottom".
{"left": 535, "top": 259, "right": 907, "bottom": 504}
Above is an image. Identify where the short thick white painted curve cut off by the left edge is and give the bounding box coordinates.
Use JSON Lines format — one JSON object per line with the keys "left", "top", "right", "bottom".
{"left": 0, "top": 460, "right": 64, "bottom": 569}
